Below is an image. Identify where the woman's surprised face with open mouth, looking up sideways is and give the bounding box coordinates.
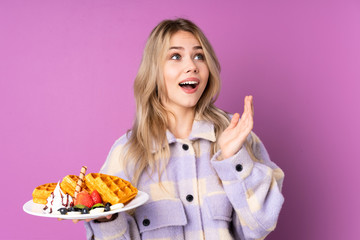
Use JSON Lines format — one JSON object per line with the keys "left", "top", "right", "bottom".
{"left": 162, "top": 31, "right": 209, "bottom": 111}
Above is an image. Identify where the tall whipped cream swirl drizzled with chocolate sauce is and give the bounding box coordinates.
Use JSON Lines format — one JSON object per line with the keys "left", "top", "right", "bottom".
{"left": 43, "top": 181, "right": 74, "bottom": 214}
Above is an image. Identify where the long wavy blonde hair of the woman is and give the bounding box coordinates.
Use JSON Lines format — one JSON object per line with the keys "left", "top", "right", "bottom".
{"left": 122, "top": 19, "right": 229, "bottom": 186}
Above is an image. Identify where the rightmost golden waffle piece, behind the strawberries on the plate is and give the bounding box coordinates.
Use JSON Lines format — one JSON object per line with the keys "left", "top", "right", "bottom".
{"left": 85, "top": 173, "right": 138, "bottom": 205}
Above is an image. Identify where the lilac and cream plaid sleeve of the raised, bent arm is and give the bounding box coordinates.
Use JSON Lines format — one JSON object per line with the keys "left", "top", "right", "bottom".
{"left": 211, "top": 132, "right": 284, "bottom": 239}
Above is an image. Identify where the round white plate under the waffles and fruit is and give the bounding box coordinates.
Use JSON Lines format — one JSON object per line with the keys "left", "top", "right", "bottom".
{"left": 23, "top": 191, "right": 149, "bottom": 219}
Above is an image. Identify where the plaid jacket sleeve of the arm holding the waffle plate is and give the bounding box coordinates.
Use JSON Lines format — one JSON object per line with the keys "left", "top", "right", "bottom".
{"left": 84, "top": 135, "right": 140, "bottom": 240}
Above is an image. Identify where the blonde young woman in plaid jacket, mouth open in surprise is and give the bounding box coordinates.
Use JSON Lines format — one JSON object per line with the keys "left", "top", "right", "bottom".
{"left": 85, "top": 19, "right": 284, "bottom": 240}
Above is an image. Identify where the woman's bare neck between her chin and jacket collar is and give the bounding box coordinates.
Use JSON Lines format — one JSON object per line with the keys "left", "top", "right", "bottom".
{"left": 168, "top": 105, "right": 195, "bottom": 139}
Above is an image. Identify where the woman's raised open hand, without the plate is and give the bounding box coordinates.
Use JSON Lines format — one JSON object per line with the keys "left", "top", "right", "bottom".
{"left": 218, "top": 96, "right": 254, "bottom": 159}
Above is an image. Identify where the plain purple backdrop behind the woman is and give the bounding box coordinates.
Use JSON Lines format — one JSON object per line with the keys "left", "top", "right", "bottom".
{"left": 0, "top": 0, "right": 360, "bottom": 240}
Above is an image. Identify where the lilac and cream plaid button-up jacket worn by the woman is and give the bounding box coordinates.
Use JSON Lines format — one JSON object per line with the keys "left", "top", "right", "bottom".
{"left": 85, "top": 117, "right": 284, "bottom": 240}
